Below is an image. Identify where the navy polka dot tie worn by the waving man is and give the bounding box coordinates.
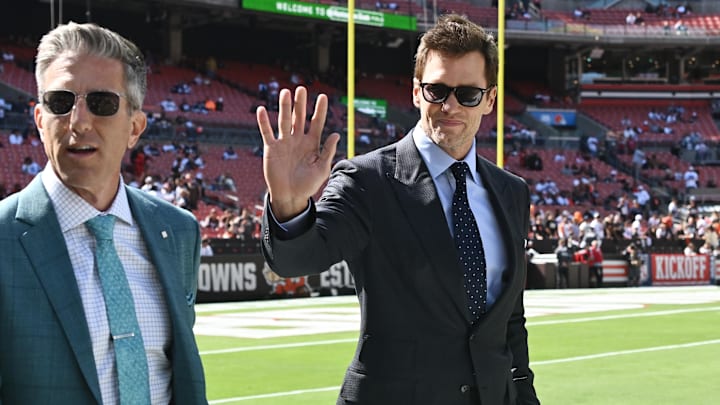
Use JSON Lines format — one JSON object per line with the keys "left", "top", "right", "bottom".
{"left": 450, "top": 162, "right": 487, "bottom": 322}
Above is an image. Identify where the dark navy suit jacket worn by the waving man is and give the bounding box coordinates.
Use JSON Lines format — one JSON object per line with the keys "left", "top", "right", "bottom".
{"left": 262, "top": 134, "right": 538, "bottom": 405}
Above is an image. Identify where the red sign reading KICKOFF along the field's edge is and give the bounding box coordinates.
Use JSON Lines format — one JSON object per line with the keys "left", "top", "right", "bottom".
{"left": 650, "top": 254, "right": 712, "bottom": 285}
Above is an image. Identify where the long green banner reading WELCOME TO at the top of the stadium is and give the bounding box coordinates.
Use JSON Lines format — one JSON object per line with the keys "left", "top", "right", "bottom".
{"left": 242, "top": 0, "right": 417, "bottom": 31}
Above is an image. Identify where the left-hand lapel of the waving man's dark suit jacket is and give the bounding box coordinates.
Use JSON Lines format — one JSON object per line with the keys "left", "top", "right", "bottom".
{"left": 392, "top": 133, "right": 470, "bottom": 322}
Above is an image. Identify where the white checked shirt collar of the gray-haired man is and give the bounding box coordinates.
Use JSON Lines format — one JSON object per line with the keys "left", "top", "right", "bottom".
{"left": 40, "top": 163, "right": 133, "bottom": 232}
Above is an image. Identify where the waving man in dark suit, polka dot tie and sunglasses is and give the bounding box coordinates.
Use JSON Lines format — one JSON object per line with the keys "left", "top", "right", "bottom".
{"left": 257, "top": 14, "right": 539, "bottom": 405}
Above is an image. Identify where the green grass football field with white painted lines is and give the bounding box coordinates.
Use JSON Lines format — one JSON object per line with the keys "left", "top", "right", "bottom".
{"left": 195, "top": 286, "right": 720, "bottom": 405}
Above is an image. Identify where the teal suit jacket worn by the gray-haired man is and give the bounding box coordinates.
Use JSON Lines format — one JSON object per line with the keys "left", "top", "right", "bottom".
{"left": 0, "top": 176, "right": 207, "bottom": 405}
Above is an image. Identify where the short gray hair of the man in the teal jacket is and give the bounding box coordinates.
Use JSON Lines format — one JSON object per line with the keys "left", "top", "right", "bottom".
{"left": 35, "top": 22, "right": 147, "bottom": 110}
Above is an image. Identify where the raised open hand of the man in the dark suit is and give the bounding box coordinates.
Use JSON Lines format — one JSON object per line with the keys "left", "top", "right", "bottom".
{"left": 257, "top": 86, "right": 340, "bottom": 222}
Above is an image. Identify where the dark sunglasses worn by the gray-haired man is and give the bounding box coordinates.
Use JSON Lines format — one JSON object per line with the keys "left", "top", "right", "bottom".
{"left": 42, "top": 90, "right": 125, "bottom": 117}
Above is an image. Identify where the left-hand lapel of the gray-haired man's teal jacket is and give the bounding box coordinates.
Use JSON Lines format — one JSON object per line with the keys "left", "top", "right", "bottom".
{"left": 17, "top": 176, "right": 101, "bottom": 403}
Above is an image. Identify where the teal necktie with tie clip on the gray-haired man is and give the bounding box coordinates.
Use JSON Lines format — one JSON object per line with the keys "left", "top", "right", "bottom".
{"left": 85, "top": 215, "right": 150, "bottom": 405}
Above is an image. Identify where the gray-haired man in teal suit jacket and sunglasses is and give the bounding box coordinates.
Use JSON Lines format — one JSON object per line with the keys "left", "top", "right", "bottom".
{"left": 0, "top": 23, "right": 207, "bottom": 404}
